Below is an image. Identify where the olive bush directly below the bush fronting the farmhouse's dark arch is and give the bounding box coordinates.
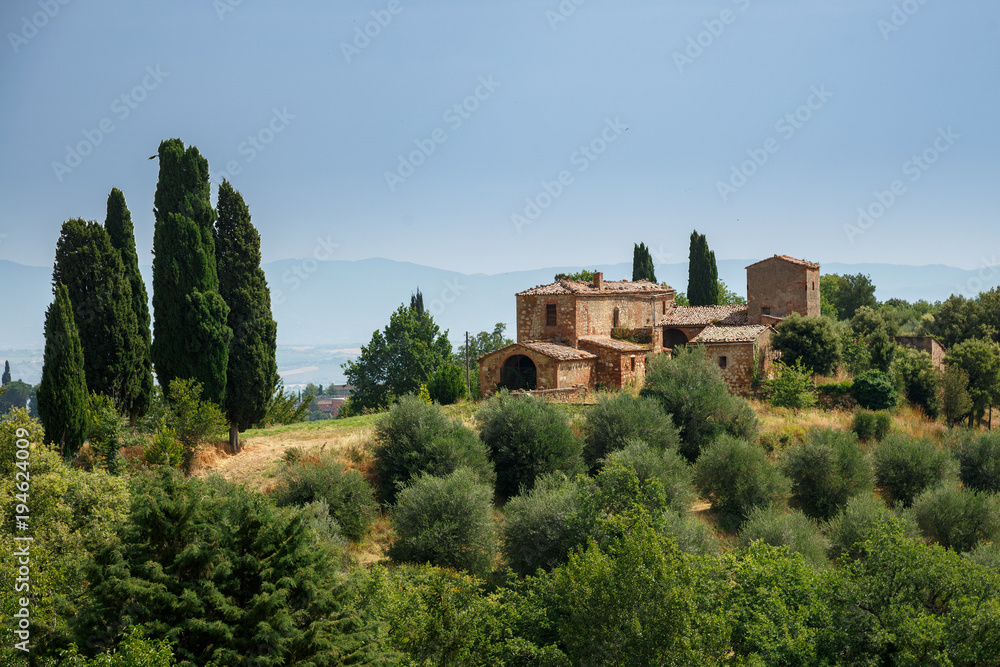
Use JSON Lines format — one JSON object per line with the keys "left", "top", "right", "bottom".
{"left": 503, "top": 473, "right": 586, "bottom": 576}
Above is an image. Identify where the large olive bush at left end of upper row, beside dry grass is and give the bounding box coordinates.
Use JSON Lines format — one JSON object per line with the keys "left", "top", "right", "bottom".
{"left": 374, "top": 395, "right": 495, "bottom": 505}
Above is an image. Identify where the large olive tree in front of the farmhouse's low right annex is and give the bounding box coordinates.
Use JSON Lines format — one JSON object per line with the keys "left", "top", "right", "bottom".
{"left": 640, "top": 346, "right": 758, "bottom": 461}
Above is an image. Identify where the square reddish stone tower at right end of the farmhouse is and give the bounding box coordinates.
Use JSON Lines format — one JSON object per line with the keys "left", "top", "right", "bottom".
{"left": 747, "top": 258, "right": 820, "bottom": 324}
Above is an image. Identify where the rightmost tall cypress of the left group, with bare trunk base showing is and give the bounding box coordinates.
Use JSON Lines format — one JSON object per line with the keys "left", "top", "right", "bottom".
{"left": 215, "top": 180, "right": 278, "bottom": 451}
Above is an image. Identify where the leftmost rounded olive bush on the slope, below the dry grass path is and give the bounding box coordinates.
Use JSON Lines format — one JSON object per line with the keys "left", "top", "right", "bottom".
{"left": 271, "top": 454, "right": 378, "bottom": 542}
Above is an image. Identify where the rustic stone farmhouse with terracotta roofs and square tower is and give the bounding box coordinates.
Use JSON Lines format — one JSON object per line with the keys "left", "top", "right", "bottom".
{"left": 479, "top": 255, "right": 820, "bottom": 397}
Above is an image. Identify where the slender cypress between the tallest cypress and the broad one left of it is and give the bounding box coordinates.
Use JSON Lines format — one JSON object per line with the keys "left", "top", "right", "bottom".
{"left": 104, "top": 188, "right": 153, "bottom": 424}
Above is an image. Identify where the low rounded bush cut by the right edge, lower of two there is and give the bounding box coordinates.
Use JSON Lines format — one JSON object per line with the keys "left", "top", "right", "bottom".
{"left": 913, "top": 484, "right": 1000, "bottom": 552}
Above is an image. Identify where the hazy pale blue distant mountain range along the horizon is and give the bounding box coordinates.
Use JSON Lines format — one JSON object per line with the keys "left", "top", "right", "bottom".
{"left": 0, "top": 258, "right": 1000, "bottom": 385}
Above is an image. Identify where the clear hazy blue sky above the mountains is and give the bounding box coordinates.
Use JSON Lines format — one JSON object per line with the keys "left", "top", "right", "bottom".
{"left": 0, "top": 0, "right": 1000, "bottom": 273}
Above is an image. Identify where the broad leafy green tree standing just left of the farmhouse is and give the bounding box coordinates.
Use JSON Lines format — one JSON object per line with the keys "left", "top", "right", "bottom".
{"left": 343, "top": 305, "right": 451, "bottom": 414}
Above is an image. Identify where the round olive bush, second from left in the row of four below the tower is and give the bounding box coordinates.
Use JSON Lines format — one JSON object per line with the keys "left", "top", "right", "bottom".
{"left": 781, "top": 429, "right": 874, "bottom": 521}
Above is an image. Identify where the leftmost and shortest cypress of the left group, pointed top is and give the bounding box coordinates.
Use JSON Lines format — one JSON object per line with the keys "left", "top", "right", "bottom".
{"left": 37, "top": 285, "right": 87, "bottom": 456}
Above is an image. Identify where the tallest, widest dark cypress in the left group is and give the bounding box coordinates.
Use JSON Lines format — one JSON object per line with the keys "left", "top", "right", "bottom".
{"left": 152, "top": 139, "right": 233, "bottom": 403}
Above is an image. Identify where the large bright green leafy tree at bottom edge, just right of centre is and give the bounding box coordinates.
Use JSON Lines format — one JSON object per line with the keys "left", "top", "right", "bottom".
{"left": 551, "top": 521, "right": 730, "bottom": 667}
